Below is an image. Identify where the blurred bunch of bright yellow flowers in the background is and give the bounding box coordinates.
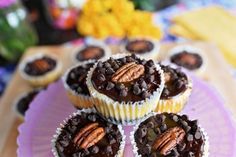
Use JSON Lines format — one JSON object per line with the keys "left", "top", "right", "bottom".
{"left": 77, "top": 0, "right": 162, "bottom": 39}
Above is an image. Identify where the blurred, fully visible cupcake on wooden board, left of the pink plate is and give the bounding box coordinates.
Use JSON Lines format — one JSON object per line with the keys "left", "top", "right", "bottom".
{"left": 20, "top": 53, "right": 62, "bottom": 87}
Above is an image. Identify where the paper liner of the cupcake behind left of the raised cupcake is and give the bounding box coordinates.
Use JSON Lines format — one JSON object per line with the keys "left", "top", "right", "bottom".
{"left": 62, "top": 60, "right": 96, "bottom": 109}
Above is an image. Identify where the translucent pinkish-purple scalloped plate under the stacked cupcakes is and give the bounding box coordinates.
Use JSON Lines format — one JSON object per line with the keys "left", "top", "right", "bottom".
{"left": 17, "top": 77, "right": 236, "bottom": 157}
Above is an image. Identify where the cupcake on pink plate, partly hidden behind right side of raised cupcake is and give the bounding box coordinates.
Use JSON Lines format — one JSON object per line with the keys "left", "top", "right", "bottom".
{"left": 154, "top": 65, "right": 192, "bottom": 113}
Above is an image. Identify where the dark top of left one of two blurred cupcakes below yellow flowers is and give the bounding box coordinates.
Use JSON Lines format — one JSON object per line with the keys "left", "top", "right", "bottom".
{"left": 75, "top": 45, "right": 106, "bottom": 61}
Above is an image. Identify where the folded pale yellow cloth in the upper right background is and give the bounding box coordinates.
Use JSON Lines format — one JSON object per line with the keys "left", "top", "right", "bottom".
{"left": 170, "top": 6, "right": 236, "bottom": 67}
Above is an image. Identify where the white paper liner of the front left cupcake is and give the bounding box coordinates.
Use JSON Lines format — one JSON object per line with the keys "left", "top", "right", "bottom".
{"left": 51, "top": 108, "right": 126, "bottom": 157}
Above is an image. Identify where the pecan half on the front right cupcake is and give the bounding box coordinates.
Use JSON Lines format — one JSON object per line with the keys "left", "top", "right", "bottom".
{"left": 153, "top": 127, "right": 185, "bottom": 155}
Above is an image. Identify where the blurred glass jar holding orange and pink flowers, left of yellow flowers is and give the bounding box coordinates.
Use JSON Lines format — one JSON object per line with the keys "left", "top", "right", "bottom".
{"left": 44, "top": 0, "right": 86, "bottom": 30}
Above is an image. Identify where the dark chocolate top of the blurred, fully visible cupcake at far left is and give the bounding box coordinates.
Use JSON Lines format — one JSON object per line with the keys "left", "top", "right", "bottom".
{"left": 23, "top": 55, "right": 57, "bottom": 76}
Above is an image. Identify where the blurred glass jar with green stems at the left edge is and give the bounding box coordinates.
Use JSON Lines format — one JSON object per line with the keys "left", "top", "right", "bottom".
{"left": 0, "top": 0, "right": 37, "bottom": 62}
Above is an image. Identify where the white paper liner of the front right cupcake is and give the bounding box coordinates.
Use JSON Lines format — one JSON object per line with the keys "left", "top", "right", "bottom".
{"left": 130, "top": 112, "right": 209, "bottom": 157}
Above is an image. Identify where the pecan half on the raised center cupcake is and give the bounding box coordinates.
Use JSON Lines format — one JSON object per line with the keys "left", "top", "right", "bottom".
{"left": 112, "top": 62, "right": 145, "bottom": 83}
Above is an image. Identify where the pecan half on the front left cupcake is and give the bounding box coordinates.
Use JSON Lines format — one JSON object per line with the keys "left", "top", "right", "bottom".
{"left": 73, "top": 123, "right": 105, "bottom": 149}
